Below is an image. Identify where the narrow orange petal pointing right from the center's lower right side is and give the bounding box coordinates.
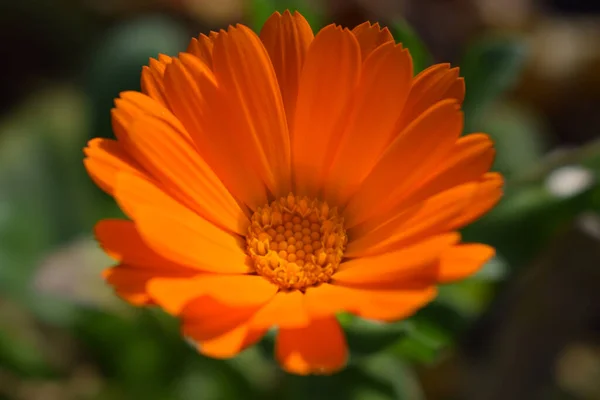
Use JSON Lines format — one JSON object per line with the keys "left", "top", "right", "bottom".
{"left": 333, "top": 233, "right": 460, "bottom": 286}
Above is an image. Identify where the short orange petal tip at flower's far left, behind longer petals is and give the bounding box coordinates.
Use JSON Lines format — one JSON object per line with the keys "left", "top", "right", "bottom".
{"left": 83, "top": 138, "right": 142, "bottom": 196}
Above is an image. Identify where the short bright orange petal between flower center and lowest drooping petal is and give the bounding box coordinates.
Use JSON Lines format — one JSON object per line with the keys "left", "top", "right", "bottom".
{"left": 250, "top": 290, "right": 310, "bottom": 329}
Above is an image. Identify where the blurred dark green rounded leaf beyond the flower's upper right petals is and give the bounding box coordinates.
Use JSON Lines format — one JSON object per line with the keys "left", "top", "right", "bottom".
{"left": 461, "top": 37, "right": 527, "bottom": 132}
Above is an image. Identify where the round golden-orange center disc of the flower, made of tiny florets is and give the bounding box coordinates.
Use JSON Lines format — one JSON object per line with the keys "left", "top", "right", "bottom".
{"left": 246, "top": 194, "right": 348, "bottom": 290}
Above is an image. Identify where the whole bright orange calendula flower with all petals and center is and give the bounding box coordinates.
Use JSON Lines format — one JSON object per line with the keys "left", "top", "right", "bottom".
{"left": 85, "top": 12, "right": 502, "bottom": 374}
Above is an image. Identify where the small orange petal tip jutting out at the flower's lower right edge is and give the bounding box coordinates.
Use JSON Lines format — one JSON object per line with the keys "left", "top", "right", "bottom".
{"left": 438, "top": 243, "right": 496, "bottom": 283}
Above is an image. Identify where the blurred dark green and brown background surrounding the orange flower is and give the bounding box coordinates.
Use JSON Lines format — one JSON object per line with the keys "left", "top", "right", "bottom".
{"left": 0, "top": 0, "right": 600, "bottom": 400}
